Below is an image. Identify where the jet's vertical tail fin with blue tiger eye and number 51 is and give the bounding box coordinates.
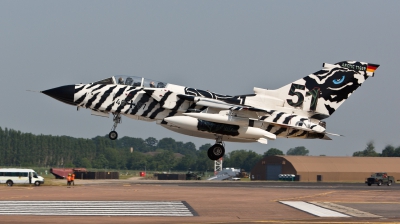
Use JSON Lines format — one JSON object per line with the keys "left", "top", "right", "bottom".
{"left": 264, "top": 61, "right": 379, "bottom": 119}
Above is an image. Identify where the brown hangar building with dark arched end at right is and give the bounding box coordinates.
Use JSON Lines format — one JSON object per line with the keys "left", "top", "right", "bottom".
{"left": 251, "top": 156, "right": 400, "bottom": 182}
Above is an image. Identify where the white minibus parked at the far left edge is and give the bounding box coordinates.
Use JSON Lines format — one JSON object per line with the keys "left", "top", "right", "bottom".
{"left": 0, "top": 168, "right": 44, "bottom": 187}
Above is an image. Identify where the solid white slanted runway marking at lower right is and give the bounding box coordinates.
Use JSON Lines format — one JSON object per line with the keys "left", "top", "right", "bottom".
{"left": 280, "top": 201, "right": 350, "bottom": 217}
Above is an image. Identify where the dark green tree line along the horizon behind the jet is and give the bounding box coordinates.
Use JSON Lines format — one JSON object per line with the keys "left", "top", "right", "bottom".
{"left": 0, "top": 127, "right": 394, "bottom": 171}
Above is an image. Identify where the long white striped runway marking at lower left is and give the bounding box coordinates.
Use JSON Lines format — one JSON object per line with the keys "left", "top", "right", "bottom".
{"left": 0, "top": 201, "right": 197, "bottom": 216}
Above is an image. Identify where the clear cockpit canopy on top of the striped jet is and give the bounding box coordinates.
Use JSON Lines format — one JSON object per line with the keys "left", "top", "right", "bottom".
{"left": 93, "top": 75, "right": 167, "bottom": 88}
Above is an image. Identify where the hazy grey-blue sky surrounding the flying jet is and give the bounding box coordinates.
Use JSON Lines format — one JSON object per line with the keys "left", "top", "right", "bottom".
{"left": 0, "top": 1, "right": 400, "bottom": 156}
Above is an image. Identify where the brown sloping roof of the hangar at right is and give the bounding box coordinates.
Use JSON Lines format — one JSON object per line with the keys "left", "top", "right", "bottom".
{"left": 279, "top": 156, "right": 400, "bottom": 174}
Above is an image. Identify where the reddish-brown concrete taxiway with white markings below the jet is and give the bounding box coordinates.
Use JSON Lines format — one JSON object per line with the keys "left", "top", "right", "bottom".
{"left": 0, "top": 180, "right": 400, "bottom": 223}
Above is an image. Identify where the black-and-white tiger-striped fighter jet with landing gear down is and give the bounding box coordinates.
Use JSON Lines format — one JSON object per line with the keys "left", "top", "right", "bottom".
{"left": 42, "top": 61, "right": 379, "bottom": 160}
